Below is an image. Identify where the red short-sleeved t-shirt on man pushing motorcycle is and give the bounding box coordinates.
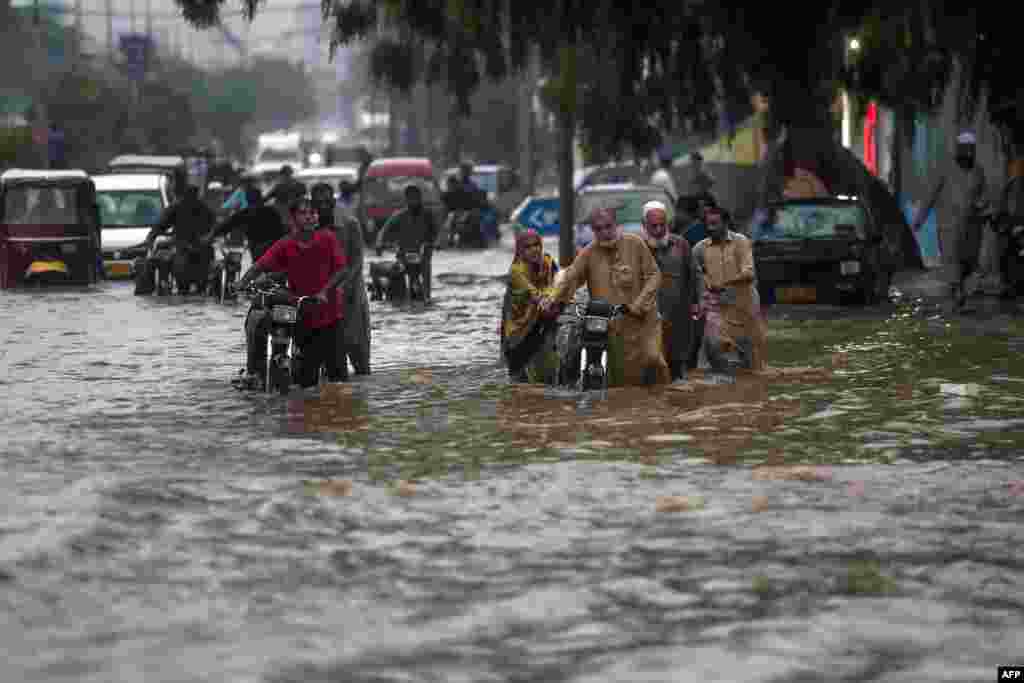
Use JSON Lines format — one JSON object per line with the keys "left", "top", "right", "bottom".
{"left": 256, "top": 230, "right": 348, "bottom": 330}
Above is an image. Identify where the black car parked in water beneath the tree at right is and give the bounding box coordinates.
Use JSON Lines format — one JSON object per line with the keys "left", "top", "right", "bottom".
{"left": 751, "top": 197, "right": 899, "bottom": 304}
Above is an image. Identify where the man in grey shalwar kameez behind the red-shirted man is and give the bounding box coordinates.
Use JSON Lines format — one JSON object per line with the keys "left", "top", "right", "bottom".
{"left": 312, "top": 183, "right": 370, "bottom": 375}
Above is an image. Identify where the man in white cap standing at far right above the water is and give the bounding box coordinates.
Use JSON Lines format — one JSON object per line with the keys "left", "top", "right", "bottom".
{"left": 913, "top": 130, "right": 987, "bottom": 308}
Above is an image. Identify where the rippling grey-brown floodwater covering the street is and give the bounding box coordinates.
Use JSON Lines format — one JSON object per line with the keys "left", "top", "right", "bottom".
{"left": 0, "top": 233, "right": 1024, "bottom": 683}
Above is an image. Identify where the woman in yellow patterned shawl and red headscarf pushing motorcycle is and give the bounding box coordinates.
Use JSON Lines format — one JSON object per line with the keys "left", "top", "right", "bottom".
{"left": 500, "top": 230, "right": 558, "bottom": 382}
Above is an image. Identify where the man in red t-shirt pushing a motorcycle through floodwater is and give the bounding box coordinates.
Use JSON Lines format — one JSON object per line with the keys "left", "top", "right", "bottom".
{"left": 238, "top": 198, "right": 348, "bottom": 387}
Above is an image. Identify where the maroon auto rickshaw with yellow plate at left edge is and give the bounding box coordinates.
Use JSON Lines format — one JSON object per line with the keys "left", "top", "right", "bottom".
{"left": 0, "top": 169, "right": 101, "bottom": 289}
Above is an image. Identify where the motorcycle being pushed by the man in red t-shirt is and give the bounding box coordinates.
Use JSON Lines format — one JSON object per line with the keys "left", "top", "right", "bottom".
{"left": 236, "top": 281, "right": 312, "bottom": 394}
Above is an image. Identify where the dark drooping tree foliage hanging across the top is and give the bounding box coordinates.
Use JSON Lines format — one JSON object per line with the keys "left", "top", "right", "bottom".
{"left": 169, "top": 0, "right": 1024, "bottom": 152}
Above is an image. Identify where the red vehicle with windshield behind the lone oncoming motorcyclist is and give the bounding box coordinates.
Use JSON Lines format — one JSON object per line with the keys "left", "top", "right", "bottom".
{"left": 356, "top": 157, "right": 444, "bottom": 245}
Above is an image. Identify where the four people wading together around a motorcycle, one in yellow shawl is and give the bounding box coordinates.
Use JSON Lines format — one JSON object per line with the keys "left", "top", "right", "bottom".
{"left": 500, "top": 202, "right": 767, "bottom": 386}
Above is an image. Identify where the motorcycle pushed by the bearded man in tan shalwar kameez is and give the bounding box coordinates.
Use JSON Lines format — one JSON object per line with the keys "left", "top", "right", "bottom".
{"left": 555, "top": 299, "right": 626, "bottom": 391}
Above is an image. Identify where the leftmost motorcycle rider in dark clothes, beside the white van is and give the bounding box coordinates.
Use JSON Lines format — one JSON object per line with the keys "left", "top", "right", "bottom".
{"left": 145, "top": 185, "right": 217, "bottom": 294}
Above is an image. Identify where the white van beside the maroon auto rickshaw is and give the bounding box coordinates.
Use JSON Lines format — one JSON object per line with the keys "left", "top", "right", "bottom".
{"left": 92, "top": 173, "right": 171, "bottom": 278}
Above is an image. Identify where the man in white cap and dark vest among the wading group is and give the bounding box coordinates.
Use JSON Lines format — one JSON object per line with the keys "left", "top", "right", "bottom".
{"left": 643, "top": 201, "right": 697, "bottom": 381}
